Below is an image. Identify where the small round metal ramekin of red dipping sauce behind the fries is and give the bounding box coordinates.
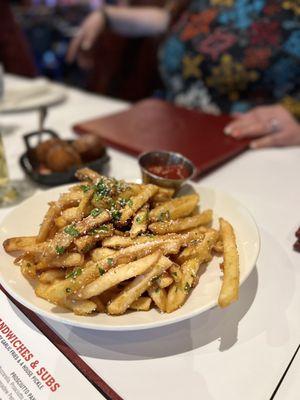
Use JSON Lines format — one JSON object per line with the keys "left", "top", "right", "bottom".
{"left": 138, "top": 150, "right": 196, "bottom": 190}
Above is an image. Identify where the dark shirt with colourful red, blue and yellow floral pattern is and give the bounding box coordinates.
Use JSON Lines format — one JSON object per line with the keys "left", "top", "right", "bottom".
{"left": 159, "top": 0, "right": 300, "bottom": 117}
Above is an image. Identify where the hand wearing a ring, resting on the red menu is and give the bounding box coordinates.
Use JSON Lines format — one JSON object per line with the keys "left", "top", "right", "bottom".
{"left": 224, "top": 105, "right": 300, "bottom": 149}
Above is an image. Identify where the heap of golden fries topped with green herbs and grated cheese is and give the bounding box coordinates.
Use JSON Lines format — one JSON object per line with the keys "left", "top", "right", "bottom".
{"left": 3, "top": 168, "right": 239, "bottom": 315}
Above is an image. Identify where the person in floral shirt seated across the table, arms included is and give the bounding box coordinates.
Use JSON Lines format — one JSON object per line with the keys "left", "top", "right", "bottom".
{"left": 68, "top": 0, "right": 300, "bottom": 148}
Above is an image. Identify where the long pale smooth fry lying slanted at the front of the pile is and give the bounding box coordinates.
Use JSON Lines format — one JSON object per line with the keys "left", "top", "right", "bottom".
{"left": 76, "top": 251, "right": 161, "bottom": 299}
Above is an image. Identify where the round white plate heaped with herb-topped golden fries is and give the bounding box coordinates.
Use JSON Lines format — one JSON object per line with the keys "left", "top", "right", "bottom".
{"left": 0, "top": 168, "right": 260, "bottom": 331}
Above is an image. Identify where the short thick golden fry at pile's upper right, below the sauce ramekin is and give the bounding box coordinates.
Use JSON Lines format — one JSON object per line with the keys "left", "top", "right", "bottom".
{"left": 149, "top": 194, "right": 199, "bottom": 222}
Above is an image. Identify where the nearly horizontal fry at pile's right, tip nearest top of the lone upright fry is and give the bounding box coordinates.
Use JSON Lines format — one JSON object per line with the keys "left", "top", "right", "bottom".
{"left": 149, "top": 210, "right": 212, "bottom": 235}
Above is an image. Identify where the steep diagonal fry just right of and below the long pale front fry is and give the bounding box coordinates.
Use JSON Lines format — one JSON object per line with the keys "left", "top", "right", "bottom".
{"left": 107, "top": 256, "right": 172, "bottom": 315}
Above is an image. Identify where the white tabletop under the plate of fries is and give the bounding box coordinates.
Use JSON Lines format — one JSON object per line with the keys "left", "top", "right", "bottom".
{"left": 0, "top": 77, "right": 300, "bottom": 400}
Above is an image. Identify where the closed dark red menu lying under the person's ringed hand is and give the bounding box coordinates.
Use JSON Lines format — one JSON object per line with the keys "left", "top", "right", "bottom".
{"left": 74, "top": 99, "right": 249, "bottom": 175}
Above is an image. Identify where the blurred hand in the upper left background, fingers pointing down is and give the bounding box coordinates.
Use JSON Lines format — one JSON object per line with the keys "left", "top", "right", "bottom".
{"left": 66, "top": 10, "right": 106, "bottom": 63}
